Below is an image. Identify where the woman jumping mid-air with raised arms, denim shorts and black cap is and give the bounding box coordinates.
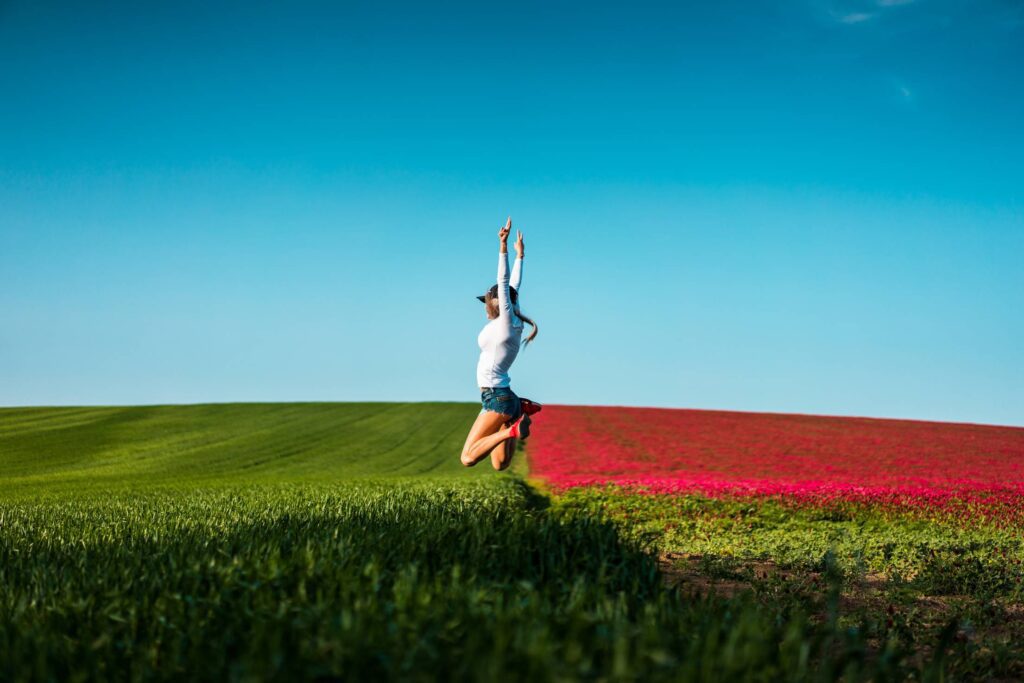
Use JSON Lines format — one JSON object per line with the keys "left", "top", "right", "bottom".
{"left": 462, "top": 216, "right": 541, "bottom": 470}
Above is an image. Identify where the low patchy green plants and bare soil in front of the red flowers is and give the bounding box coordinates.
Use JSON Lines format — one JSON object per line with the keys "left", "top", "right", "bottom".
{"left": 558, "top": 486, "right": 1024, "bottom": 681}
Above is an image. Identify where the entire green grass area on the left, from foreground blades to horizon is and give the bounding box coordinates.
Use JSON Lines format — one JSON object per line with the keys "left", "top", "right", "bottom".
{"left": 0, "top": 403, "right": 945, "bottom": 681}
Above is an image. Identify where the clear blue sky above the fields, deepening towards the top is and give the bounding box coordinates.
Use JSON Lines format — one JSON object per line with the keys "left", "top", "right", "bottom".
{"left": 0, "top": 0, "right": 1024, "bottom": 425}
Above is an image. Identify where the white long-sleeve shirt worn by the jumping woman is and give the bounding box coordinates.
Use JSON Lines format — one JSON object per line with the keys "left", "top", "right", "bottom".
{"left": 476, "top": 252, "right": 523, "bottom": 388}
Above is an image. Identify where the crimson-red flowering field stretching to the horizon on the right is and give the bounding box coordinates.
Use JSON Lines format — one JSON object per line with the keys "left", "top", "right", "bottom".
{"left": 529, "top": 405, "right": 1024, "bottom": 520}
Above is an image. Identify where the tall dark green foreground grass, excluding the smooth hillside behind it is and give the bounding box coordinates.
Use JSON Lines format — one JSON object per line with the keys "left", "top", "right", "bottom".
{"left": 0, "top": 478, "right": 958, "bottom": 681}
